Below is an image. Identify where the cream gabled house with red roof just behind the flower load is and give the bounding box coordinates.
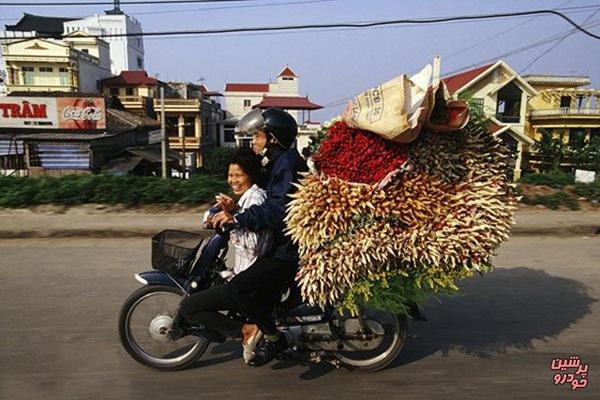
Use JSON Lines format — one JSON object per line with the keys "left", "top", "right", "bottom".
{"left": 444, "top": 60, "right": 538, "bottom": 179}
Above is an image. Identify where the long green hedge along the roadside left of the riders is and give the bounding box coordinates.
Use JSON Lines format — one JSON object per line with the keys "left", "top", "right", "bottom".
{"left": 0, "top": 175, "right": 229, "bottom": 207}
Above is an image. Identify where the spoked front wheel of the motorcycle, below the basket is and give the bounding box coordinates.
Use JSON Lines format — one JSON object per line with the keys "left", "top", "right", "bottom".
{"left": 119, "top": 286, "right": 208, "bottom": 371}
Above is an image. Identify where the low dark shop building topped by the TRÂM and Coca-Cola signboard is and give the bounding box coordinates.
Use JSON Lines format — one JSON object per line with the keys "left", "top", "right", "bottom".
{"left": 0, "top": 92, "right": 179, "bottom": 176}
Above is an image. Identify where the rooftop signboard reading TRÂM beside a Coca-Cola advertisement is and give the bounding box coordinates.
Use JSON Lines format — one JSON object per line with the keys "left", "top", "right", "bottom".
{"left": 0, "top": 97, "right": 106, "bottom": 130}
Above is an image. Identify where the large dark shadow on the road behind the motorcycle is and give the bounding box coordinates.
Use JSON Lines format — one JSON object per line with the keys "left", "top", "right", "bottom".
{"left": 390, "top": 267, "right": 597, "bottom": 368}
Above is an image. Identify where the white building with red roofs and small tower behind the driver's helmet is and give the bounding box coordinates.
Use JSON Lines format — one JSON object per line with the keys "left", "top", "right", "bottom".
{"left": 223, "top": 66, "right": 322, "bottom": 146}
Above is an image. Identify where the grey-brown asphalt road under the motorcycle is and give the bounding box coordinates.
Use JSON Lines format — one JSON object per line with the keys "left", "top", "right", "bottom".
{"left": 0, "top": 237, "right": 600, "bottom": 400}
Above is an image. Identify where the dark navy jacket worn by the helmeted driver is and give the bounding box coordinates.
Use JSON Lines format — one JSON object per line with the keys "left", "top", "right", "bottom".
{"left": 236, "top": 149, "right": 308, "bottom": 261}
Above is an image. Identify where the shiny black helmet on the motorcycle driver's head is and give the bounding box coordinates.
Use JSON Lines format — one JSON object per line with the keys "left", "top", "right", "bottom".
{"left": 235, "top": 107, "right": 298, "bottom": 149}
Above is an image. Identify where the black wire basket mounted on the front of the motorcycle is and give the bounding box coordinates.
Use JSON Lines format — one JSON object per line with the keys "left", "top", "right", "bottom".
{"left": 152, "top": 229, "right": 208, "bottom": 277}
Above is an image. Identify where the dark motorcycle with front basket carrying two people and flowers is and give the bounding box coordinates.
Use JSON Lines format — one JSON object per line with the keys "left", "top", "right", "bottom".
{"left": 119, "top": 225, "right": 407, "bottom": 372}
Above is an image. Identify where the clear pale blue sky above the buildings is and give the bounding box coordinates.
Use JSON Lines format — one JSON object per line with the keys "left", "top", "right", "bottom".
{"left": 0, "top": 0, "right": 600, "bottom": 121}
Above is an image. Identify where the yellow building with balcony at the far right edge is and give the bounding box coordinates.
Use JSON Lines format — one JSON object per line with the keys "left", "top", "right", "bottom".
{"left": 523, "top": 74, "right": 600, "bottom": 170}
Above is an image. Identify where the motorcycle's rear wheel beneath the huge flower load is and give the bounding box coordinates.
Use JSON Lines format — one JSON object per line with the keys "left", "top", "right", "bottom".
{"left": 335, "top": 308, "right": 408, "bottom": 372}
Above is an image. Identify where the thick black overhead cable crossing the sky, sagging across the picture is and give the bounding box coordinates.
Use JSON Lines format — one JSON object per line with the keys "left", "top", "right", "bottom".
{"left": 17, "top": 10, "right": 600, "bottom": 40}
